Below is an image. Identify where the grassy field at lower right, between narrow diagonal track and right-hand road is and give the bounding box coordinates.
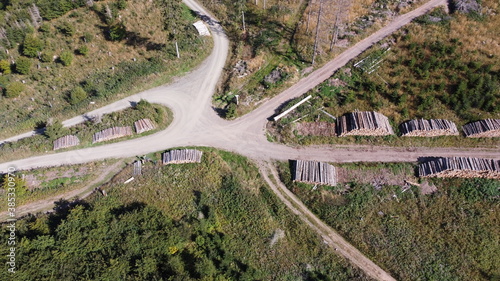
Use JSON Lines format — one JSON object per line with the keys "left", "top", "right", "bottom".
{"left": 279, "top": 160, "right": 500, "bottom": 280}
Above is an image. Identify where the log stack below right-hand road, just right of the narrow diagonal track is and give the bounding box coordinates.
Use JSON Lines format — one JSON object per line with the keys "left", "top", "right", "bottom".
{"left": 293, "top": 160, "right": 337, "bottom": 185}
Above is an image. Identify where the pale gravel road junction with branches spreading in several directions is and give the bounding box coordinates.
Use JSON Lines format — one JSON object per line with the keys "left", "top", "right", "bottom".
{"left": 0, "top": 0, "right": 500, "bottom": 280}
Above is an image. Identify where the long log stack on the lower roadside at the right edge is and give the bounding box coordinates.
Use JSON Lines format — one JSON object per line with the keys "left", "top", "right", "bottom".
{"left": 418, "top": 157, "right": 500, "bottom": 179}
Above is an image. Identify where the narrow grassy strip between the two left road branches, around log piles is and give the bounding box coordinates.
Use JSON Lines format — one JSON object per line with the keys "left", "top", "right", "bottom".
{"left": 0, "top": 101, "right": 173, "bottom": 161}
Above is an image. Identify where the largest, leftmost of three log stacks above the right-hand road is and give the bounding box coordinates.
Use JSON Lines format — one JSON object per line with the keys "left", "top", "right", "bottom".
{"left": 337, "top": 111, "right": 394, "bottom": 137}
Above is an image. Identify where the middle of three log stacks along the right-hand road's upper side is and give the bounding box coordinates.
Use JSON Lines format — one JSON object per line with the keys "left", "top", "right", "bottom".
{"left": 399, "top": 119, "right": 458, "bottom": 137}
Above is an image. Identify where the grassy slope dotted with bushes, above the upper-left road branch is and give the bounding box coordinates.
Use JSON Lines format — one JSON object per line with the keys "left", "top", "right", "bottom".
{"left": 0, "top": 0, "right": 213, "bottom": 138}
